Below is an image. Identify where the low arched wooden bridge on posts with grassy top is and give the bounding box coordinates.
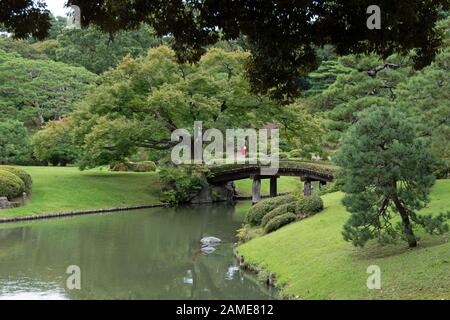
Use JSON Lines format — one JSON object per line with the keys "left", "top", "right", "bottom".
{"left": 208, "top": 161, "right": 336, "bottom": 203}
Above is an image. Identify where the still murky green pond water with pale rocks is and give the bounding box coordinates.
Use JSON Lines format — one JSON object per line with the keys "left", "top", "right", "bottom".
{"left": 0, "top": 204, "right": 271, "bottom": 299}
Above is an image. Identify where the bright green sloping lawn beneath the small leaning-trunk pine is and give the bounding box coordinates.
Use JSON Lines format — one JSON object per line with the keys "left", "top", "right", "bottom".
{"left": 238, "top": 180, "right": 450, "bottom": 299}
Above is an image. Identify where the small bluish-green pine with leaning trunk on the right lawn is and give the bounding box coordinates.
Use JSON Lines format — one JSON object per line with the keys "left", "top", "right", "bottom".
{"left": 336, "top": 106, "right": 448, "bottom": 247}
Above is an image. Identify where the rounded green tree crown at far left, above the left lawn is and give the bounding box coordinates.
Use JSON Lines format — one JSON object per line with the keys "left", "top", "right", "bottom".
{"left": 0, "top": 51, "right": 95, "bottom": 129}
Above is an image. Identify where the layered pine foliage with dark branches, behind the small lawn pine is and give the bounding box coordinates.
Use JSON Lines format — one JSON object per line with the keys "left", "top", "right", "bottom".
{"left": 311, "top": 55, "right": 412, "bottom": 148}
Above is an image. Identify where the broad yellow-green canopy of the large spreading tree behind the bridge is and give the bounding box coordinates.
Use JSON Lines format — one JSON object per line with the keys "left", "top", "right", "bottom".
{"left": 73, "top": 46, "right": 318, "bottom": 166}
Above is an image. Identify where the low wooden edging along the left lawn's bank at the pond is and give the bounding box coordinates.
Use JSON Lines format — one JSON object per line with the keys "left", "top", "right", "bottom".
{"left": 0, "top": 203, "right": 166, "bottom": 224}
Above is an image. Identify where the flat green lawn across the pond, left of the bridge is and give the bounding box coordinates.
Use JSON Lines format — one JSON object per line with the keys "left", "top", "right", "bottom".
{"left": 0, "top": 167, "right": 160, "bottom": 218}
